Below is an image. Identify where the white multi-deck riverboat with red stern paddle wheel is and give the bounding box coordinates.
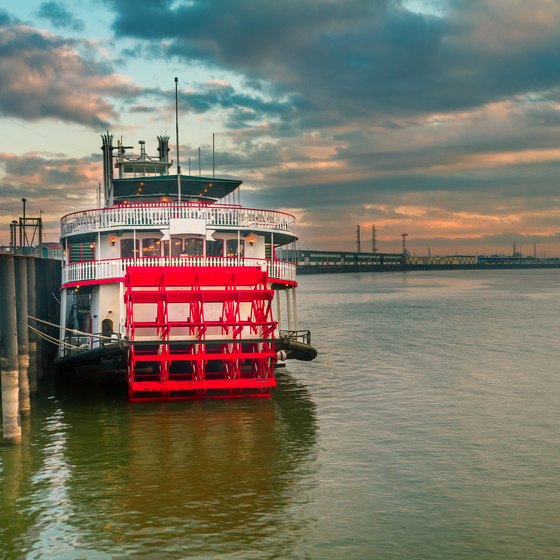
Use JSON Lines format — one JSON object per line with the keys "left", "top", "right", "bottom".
{"left": 57, "top": 132, "right": 317, "bottom": 401}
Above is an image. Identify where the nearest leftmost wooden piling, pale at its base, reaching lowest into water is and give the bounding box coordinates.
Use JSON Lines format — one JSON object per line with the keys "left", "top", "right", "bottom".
{"left": 0, "top": 255, "right": 21, "bottom": 444}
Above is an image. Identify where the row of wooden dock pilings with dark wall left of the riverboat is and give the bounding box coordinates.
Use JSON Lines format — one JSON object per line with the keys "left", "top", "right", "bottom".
{"left": 0, "top": 254, "right": 61, "bottom": 444}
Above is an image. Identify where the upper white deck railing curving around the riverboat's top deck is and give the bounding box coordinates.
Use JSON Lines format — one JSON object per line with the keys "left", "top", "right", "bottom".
{"left": 60, "top": 203, "right": 295, "bottom": 236}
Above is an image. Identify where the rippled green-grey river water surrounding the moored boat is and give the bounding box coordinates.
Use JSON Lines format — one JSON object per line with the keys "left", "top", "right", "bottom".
{"left": 0, "top": 270, "right": 560, "bottom": 560}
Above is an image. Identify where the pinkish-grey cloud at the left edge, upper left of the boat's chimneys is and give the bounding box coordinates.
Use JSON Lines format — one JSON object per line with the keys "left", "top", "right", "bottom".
{"left": 0, "top": 12, "right": 141, "bottom": 130}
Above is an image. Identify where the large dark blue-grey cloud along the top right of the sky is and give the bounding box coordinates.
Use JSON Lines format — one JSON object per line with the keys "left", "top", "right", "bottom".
{"left": 107, "top": 0, "right": 560, "bottom": 126}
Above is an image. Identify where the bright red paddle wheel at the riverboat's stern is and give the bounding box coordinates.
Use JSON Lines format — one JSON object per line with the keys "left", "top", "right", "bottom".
{"left": 124, "top": 267, "right": 277, "bottom": 400}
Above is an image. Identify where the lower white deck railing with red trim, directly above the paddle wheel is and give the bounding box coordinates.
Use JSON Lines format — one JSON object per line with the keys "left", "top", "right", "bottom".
{"left": 62, "top": 257, "right": 296, "bottom": 284}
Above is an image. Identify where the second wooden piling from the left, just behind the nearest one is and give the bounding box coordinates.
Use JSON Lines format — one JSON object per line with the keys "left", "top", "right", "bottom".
{"left": 14, "top": 256, "right": 31, "bottom": 416}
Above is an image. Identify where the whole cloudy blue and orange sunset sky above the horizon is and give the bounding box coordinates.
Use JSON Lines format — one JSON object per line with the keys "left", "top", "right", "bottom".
{"left": 0, "top": 0, "right": 560, "bottom": 256}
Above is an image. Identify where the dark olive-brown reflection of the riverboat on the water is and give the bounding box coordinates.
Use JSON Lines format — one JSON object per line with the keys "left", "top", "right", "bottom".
{"left": 0, "top": 372, "right": 317, "bottom": 558}
